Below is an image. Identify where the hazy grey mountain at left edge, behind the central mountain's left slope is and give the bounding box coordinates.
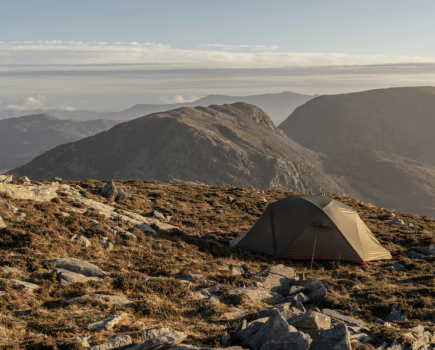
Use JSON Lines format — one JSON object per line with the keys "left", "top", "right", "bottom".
{"left": 0, "top": 114, "right": 120, "bottom": 171}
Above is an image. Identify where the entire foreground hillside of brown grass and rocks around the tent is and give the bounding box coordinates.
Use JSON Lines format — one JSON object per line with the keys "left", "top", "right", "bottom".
{"left": 0, "top": 180, "right": 435, "bottom": 350}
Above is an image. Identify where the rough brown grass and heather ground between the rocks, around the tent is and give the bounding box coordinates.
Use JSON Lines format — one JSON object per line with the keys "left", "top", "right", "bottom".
{"left": 0, "top": 180, "right": 435, "bottom": 349}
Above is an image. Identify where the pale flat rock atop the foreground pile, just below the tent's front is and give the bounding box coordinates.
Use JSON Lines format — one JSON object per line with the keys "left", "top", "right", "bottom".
{"left": 251, "top": 264, "right": 295, "bottom": 293}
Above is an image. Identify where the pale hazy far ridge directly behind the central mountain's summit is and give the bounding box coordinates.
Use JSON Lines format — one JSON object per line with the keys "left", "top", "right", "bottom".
{"left": 95, "top": 92, "right": 315, "bottom": 125}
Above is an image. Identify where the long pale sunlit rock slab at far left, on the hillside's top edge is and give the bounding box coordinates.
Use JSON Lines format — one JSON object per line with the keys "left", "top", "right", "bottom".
{"left": 0, "top": 183, "right": 58, "bottom": 202}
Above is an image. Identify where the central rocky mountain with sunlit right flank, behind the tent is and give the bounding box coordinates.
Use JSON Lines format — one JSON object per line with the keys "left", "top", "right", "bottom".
{"left": 11, "top": 102, "right": 353, "bottom": 197}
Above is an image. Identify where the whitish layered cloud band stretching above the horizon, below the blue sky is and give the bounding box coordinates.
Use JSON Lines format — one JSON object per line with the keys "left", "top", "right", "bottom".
{"left": 0, "top": 40, "right": 435, "bottom": 110}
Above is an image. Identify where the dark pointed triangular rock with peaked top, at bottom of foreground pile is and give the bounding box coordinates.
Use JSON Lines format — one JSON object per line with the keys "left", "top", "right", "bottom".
{"left": 245, "top": 310, "right": 297, "bottom": 350}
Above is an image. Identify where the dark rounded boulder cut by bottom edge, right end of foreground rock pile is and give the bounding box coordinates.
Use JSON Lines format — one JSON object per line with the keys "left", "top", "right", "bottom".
{"left": 310, "top": 323, "right": 352, "bottom": 350}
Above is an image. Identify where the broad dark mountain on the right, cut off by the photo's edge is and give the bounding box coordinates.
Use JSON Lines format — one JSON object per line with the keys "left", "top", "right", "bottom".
{"left": 280, "top": 87, "right": 435, "bottom": 217}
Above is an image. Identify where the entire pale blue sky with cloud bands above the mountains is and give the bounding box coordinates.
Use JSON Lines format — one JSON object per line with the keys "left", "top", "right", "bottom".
{"left": 0, "top": 0, "right": 435, "bottom": 111}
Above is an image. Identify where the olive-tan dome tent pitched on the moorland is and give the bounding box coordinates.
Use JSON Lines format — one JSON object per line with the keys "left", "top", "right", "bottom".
{"left": 230, "top": 195, "right": 391, "bottom": 265}
